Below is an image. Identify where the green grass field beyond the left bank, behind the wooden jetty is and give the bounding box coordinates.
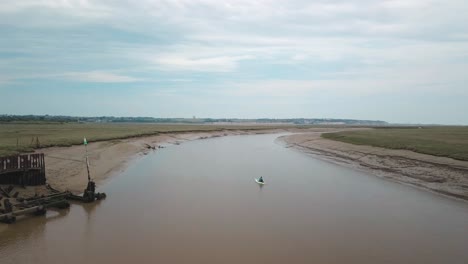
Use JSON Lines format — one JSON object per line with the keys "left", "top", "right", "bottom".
{"left": 0, "top": 123, "right": 287, "bottom": 156}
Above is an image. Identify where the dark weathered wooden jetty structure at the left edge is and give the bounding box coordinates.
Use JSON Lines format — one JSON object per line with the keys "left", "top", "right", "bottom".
{"left": 0, "top": 153, "right": 46, "bottom": 186}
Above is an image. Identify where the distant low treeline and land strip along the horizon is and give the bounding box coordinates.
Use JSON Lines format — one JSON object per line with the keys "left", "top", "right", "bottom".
{"left": 0, "top": 115, "right": 388, "bottom": 126}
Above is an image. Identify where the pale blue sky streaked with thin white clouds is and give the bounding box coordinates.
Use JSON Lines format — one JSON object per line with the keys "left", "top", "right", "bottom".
{"left": 0, "top": 0, "right": 468, "bottom": 125}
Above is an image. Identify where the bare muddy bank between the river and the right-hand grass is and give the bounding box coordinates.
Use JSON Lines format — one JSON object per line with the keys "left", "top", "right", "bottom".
{"left": 281, "top": 131, "right": 468, "bottom": 201}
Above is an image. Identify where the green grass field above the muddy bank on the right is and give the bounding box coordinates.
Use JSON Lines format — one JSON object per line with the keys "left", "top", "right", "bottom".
{"left": 322, "top": 126, "right": 468, "bottom": 160}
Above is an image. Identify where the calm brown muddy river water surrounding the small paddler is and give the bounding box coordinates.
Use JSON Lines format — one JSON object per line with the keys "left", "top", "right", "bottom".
{"left": 0, "top": 135, "right": 468, "bottom": 264}
